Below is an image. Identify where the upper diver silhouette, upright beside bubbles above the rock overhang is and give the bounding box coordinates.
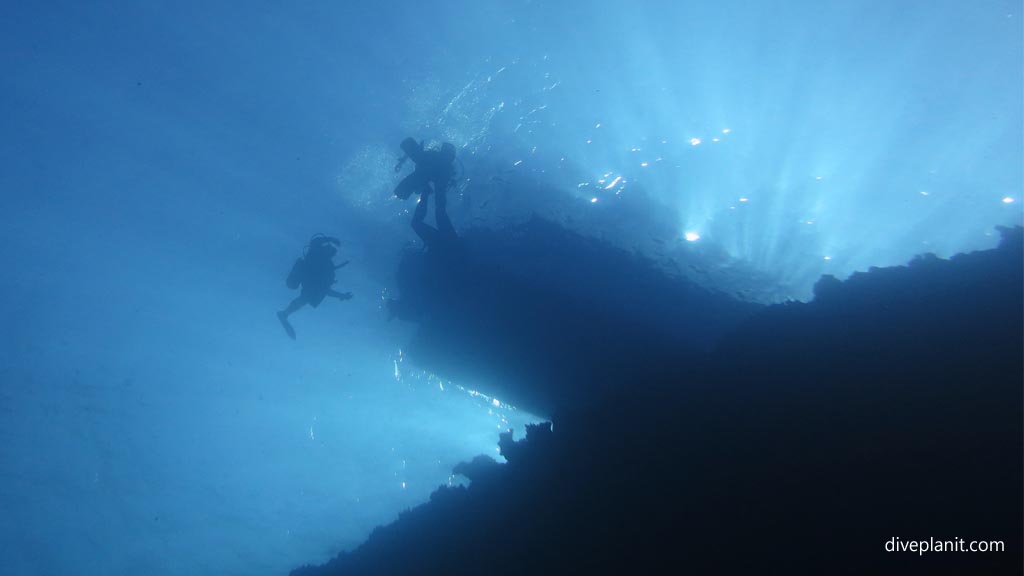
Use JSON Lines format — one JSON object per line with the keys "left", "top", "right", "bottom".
{"left": 394, "top": 138, "right": 457, "bottom": 248}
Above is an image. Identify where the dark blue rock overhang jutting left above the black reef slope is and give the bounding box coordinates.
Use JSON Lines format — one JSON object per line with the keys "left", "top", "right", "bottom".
{"left": 391, "top": 217, "right": 762, "bottom": 415}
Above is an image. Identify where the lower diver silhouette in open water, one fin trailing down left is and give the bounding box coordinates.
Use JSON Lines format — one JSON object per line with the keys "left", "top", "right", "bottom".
{"left": 278, "top": 234, "right": 352, "bottom": 340}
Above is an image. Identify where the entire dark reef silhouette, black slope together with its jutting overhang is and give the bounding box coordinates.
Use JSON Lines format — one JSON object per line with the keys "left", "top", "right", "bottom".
{"left": 292, "top": 222, "right": 1024, "bottom": 576}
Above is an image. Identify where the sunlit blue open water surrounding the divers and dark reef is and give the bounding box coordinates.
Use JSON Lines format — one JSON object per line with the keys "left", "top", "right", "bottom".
{"left": 0, "top": 0, "right": 1024, "bottom": 575}
